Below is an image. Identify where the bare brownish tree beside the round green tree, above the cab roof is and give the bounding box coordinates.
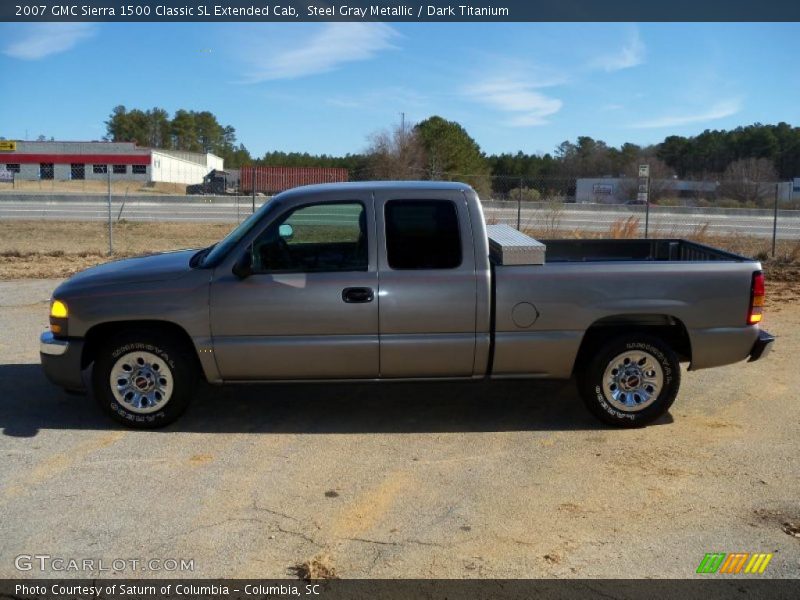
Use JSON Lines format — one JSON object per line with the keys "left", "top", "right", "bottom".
{"left": 366, "top": 121, "right": 425, "bottom": 180}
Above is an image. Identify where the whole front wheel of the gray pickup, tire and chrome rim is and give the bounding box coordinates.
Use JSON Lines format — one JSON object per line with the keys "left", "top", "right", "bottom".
{"left": 92, "top": 332, "right": 197, "bottom": 429}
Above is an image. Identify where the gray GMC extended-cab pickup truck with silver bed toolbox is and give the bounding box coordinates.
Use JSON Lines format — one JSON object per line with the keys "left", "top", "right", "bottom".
{"left": 40, "top": 182, "right": 774, "bottom": 428}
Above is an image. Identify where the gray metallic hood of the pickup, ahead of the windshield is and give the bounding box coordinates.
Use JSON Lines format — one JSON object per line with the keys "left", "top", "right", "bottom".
{"left": 53, "top": 250, "right": 197, "bottom": 296}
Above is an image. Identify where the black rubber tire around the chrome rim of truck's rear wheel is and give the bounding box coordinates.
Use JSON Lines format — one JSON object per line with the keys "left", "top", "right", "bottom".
{"left": 578, "top": 333, "right": 681, "bottom": 427}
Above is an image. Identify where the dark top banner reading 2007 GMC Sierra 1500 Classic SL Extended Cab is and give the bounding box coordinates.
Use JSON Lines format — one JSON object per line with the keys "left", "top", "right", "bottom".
{"left": 0, "top": 0, "right": 800, "bottom": 22}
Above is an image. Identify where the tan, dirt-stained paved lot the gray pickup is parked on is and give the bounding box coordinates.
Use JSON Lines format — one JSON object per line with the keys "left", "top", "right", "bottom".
{"left": 0, "top": 280, "right": 800, "bottom": 578}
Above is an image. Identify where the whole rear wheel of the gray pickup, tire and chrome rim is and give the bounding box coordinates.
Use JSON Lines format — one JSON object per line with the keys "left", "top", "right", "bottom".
{"left": 578, "top": 334, "right": 681, "bottom": 427}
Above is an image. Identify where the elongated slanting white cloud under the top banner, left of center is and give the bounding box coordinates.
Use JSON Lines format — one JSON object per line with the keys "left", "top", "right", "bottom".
{"left": 239, "top": 23, "right": 399, "bottom": 83}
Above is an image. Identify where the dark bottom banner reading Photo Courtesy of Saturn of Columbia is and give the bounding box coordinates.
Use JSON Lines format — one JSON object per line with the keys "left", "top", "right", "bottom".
{"left": 0, "top": 575, "right": 800, "bottom": 600}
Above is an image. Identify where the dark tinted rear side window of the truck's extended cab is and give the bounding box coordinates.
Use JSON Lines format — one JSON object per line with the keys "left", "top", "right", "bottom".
{"left": 385, "top": 200, "right": 461, "bottom": 270}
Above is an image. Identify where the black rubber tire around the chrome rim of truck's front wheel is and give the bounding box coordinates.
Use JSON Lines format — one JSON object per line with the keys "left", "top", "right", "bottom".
{"left": 92, "top": 330, "right": 198, "bottom": 429}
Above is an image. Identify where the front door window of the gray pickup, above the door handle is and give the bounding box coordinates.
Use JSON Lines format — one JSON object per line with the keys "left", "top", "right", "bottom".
{"left": 252, "top": 202, "right": 369, "bottom": 273}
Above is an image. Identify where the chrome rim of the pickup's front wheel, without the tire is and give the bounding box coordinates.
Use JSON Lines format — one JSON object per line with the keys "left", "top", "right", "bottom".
{"left": 109, "top": 352, "right": 173, "bottom": 415}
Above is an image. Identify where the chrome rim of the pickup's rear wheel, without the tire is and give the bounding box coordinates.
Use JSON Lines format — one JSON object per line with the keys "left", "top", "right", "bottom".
{"left": 603, "top": 350, "right": 664, "bottom": 412}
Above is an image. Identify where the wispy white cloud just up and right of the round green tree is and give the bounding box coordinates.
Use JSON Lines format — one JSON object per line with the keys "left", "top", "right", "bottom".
{"left": 465, "top": 79, "right": 563, "bottom": 127}
